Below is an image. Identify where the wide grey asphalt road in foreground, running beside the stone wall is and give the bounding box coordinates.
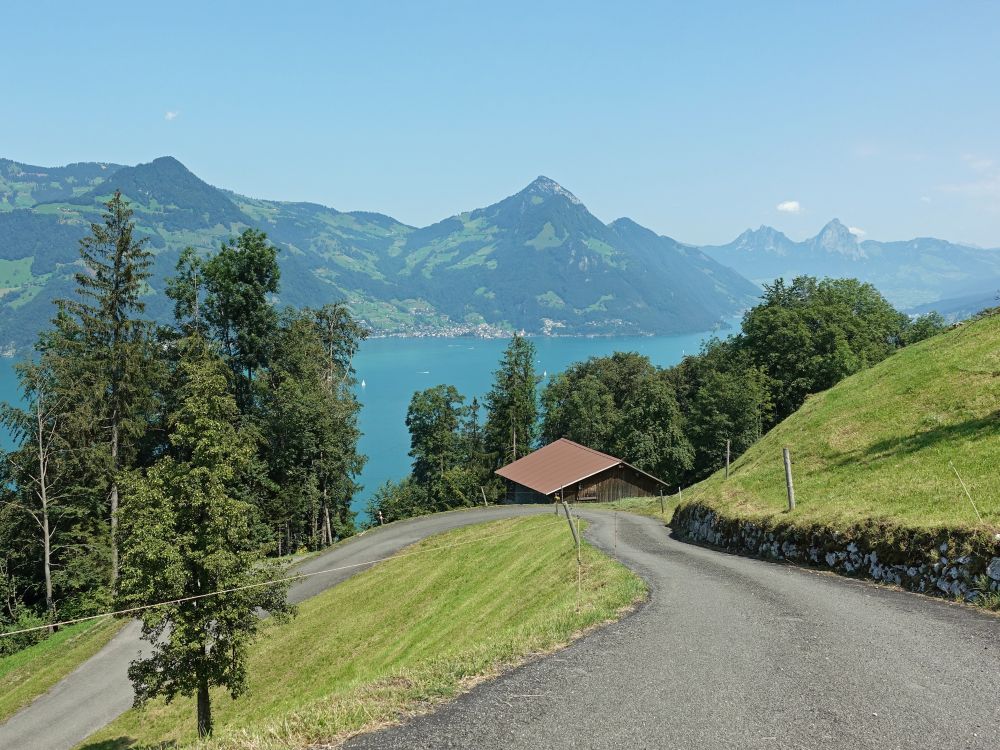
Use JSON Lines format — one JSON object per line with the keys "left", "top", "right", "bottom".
{"left": 346, "top": 512, "right": 1000, "bottom": 750}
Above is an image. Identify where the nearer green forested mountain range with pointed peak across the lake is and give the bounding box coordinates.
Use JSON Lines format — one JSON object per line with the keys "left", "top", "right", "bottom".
{"left": 0, "top": 157, "right": 760, "bottom": 351}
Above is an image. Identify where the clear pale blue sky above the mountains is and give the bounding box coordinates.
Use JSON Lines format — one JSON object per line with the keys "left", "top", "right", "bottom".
{"left": 0, "top": 0, "right": 1000, "bottom": 247}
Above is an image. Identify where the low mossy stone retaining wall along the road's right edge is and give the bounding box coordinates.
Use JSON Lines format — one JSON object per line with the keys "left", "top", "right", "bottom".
{"left": 671, "top": 503, "right": 1000, "bottom": 600}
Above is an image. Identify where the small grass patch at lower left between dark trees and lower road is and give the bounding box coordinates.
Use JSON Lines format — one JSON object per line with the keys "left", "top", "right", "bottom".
{"left": 0, "top": 620, "right": 124, "bottom": 724}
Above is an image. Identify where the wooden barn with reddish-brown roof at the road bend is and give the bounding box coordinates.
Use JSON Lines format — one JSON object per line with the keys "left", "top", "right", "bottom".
{"left": 496, "top": 438, "right": 666, "bottom": 503}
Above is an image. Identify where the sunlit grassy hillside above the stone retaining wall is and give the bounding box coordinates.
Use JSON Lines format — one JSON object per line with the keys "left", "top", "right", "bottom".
{"left": 684, "top": 316, "right": 1000, "bottom": 528}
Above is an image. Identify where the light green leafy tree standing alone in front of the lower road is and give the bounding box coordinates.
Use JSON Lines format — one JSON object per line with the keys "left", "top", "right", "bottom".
{"left": 118, "top": 335, "right": 290, "bottom": 736}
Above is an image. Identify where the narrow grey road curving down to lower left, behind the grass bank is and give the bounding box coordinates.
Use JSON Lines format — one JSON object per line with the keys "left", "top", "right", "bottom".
{"left": 0, "top": 506, "right": 552, "bottom": 750}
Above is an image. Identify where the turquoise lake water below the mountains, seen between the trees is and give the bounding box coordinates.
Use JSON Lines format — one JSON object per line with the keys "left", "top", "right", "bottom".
{"left": 0, "top": 320, "right": 739, "bottom": 510}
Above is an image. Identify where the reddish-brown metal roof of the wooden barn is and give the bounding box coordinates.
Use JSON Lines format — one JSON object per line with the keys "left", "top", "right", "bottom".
{"left": 496, "top": 438, "right": 660, "bottom": 495}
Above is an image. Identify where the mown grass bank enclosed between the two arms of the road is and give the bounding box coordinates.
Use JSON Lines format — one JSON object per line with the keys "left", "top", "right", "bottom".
{"left": 85, "top": 516, "right": 644, "bottom": 749}
